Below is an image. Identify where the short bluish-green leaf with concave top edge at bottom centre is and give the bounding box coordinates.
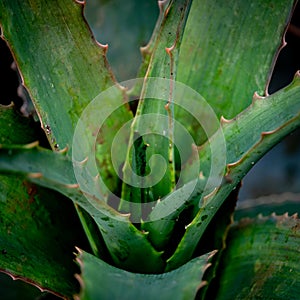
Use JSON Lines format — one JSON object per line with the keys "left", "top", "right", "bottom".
{"left": 77, "top": 250, "right": 216, "bottom": 300}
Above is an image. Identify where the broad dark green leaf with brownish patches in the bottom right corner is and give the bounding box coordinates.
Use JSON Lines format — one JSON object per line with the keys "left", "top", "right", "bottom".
{"left": 213, "top": 214, "right": 300, "bottom": 300}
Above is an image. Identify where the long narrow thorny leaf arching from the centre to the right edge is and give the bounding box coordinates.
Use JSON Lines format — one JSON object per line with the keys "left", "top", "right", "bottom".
{"left": 169, "top": 76, "right": 300, "bottom": 269}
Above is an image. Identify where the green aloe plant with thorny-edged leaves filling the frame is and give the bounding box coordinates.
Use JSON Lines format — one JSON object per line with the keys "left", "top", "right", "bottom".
{"left": 0, "top": 0, "right": 300, "bottom": 299}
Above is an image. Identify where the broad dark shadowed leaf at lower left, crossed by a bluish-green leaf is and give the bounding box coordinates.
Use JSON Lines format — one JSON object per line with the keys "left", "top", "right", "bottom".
{"left": 0, "top": 106, "right": 86, "bottom": 297}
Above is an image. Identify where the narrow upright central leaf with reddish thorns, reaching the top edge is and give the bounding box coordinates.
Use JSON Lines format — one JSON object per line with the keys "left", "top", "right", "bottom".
{"left": 121, "top": 0, "right": 190, "bottom": 217}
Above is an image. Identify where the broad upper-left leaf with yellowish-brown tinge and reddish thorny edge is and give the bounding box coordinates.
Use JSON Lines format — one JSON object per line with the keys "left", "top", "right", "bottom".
{"left": 0, "top": 0, "right": 131, "bottom": 195}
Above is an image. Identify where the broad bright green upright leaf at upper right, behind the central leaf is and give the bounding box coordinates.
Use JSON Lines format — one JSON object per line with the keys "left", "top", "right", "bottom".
{"left": 177, "top": 0, "right": 295, "bottom": 118}
